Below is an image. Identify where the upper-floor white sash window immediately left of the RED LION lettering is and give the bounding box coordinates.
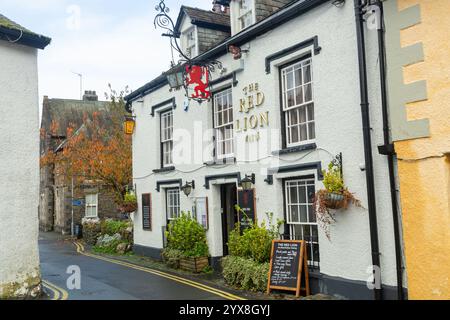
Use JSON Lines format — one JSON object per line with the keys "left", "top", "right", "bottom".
{"left": 213, "top": 88, "right": 234, "bottom": 159}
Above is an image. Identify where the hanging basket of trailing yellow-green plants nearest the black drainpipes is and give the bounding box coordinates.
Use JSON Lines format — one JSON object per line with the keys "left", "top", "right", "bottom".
{"left": 314, "top": 155, "right": 361, "bottom": 239}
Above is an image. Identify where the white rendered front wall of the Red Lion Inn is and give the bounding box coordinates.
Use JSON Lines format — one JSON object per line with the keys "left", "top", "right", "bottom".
{"left": 133, "top": 3, "right": 396, "bottom": 285}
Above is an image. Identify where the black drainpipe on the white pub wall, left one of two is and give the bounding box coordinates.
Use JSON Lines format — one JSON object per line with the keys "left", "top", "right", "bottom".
{"left": 354, "top": 0, "right": 382, "bottom": 300}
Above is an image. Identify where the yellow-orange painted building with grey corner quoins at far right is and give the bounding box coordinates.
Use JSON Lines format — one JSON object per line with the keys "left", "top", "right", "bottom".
{"left": 384, "top": 0, "right": 450, "bottom": 299}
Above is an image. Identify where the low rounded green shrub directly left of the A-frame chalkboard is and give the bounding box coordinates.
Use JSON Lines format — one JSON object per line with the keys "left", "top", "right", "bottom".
{"left": 222, "top": 256, "right": 270, "bottom": 292}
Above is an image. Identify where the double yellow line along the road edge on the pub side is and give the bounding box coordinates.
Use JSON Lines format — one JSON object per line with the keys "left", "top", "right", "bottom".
{"left": 74, "top": 242, "right": 246, "bottom": 300}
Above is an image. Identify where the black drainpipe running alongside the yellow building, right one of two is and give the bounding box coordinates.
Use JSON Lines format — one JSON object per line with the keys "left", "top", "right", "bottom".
{"left": 376, "top": 0, "right": 405, "bottom": 300}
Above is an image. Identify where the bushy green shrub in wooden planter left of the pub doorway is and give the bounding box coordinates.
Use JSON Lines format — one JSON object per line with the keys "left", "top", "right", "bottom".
{"left": 166, "top": 212, "right": 209, "bottom": 258}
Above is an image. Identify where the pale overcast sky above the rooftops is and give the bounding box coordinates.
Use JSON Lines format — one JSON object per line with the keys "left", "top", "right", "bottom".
{"left": 0, "top": 0, "right": 212, "bottom": 104}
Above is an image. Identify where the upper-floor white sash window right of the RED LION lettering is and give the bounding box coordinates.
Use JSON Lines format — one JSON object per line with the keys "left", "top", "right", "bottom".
{"left": 281, "top": 58, "right": 316, "bottom": 147}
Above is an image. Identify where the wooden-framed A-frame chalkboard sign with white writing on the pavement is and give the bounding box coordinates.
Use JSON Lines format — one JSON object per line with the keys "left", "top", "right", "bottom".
{"left": 267, "top": 240, "right": 310, "bottom": 297}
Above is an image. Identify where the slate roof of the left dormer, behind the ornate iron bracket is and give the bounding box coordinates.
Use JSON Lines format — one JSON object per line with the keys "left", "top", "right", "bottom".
{"left": 175, "top": 6, "right": 231, "bottom": 31}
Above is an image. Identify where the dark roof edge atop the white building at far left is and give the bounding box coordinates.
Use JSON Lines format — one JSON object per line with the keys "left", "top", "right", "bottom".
{"left": 0, "top": 13, "right": 51, "bottom": 49}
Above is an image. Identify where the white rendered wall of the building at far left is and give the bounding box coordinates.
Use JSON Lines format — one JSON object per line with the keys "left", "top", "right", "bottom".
{"left": 0, "top": 41, "right": 40, "bottom": 297}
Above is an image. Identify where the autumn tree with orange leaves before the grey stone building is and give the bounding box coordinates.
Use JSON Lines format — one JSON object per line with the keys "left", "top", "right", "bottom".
{"left": 41, "top": 85, "right": 132, "bottom": 205}
